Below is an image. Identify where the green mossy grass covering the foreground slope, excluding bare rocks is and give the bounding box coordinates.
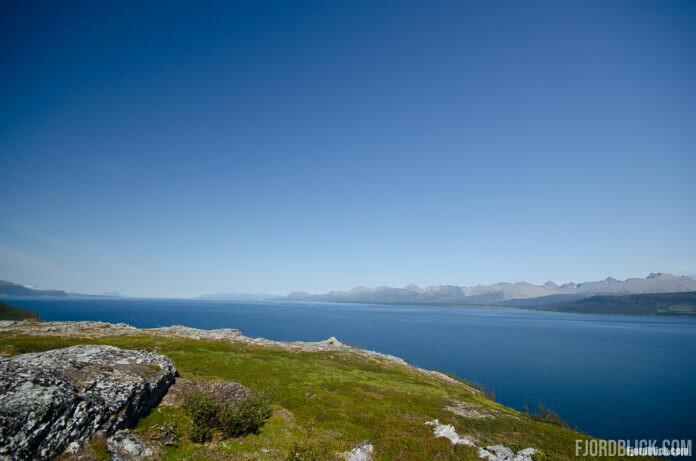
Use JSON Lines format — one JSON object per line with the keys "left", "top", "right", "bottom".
{"left": 0, "top": 334, "right": 656, "bottom": 460}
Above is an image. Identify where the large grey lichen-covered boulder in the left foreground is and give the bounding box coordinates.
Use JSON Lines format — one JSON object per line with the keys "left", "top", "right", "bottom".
{"left": 0, "top": 346, "right": 176, "bottom": 459}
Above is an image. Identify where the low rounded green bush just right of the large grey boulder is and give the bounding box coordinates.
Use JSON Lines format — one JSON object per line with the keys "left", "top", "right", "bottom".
{"left": 184, "top": 384, "right": 272, "bottom": 443}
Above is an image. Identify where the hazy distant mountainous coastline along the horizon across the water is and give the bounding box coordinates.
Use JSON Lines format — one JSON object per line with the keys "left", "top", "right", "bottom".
{"left": 5, "top": 272, "right": 696, "bottom": 317}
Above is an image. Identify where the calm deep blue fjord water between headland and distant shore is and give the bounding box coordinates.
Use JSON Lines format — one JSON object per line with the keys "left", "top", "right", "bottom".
{"left": 6, "top": 298, "right": 696, "bottom": 440}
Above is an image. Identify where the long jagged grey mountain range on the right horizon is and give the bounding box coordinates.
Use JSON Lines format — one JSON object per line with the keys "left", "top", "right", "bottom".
{"left": 286, "top": 273, "right": 696, "bottom": 307}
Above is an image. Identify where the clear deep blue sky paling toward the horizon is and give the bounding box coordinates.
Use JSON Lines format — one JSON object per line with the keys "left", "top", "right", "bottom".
{"left": 0, "top": 1, "right": 696, "bottom": 296}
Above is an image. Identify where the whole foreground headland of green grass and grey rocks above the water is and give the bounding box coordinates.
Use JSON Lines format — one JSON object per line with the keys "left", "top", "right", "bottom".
{"left": 0, "top": 321, "right": 656, "bottom": 460}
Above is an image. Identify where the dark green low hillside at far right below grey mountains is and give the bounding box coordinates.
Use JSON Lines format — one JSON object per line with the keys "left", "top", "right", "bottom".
{"left": 533, "top": 291, "right": 696, "bottom": 317}
